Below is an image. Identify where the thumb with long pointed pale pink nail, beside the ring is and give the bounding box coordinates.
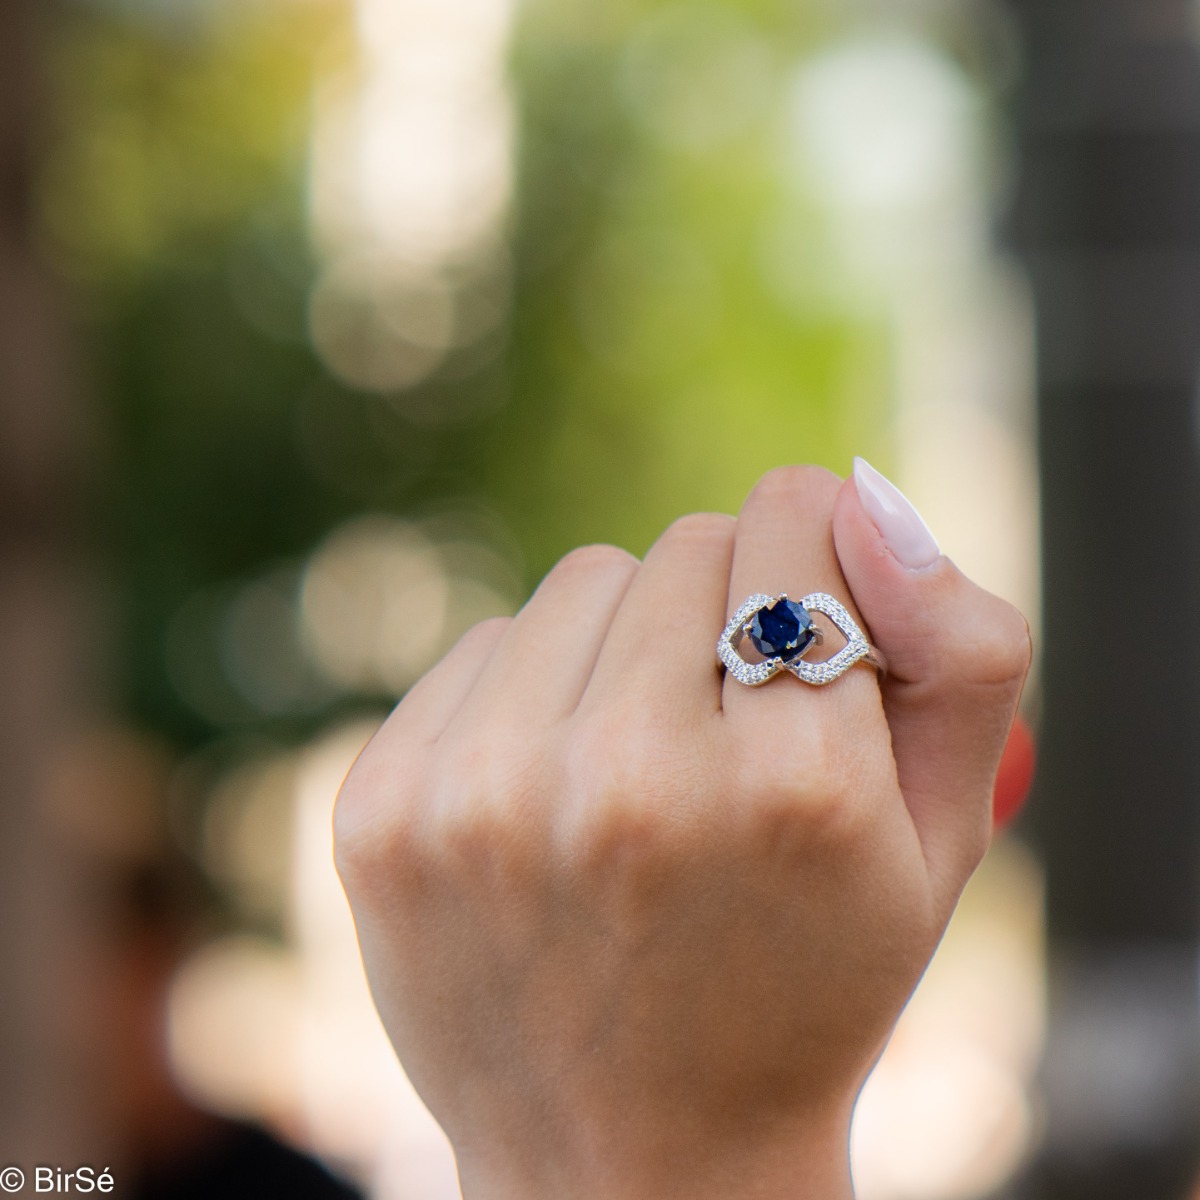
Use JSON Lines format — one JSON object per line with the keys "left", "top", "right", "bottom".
{"left": 833, "top": 458, "right": 1030, "bottom": 904}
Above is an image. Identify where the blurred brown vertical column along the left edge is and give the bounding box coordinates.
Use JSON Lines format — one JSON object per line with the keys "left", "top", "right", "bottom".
{"left": 0, "top": 0, "right": 104, "bottom": 1166}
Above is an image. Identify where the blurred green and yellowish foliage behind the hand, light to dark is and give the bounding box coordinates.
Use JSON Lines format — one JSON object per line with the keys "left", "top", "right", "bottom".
{"left": 40, "top": 0, "right": 888, "bottom": 746}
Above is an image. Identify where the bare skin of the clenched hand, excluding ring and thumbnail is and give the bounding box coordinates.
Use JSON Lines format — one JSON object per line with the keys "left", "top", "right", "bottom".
{"left": 335, "top": 467, "right": 1030, "bottom": 1200}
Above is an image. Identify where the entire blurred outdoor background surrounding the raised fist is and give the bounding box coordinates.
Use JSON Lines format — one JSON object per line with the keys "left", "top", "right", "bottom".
{"left": 0, "top": 0, "right": 1200, "bottom": 1200}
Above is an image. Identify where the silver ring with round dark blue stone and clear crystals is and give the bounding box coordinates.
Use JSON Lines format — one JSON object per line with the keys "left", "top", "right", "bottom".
{"left": 716, "top": 592, "right": 886, "bottom": 688}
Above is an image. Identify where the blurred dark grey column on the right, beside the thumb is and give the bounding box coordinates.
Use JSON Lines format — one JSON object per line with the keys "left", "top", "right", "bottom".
{"left": 1008, "top": 0, "right": 1200, "bottom": 1200}
